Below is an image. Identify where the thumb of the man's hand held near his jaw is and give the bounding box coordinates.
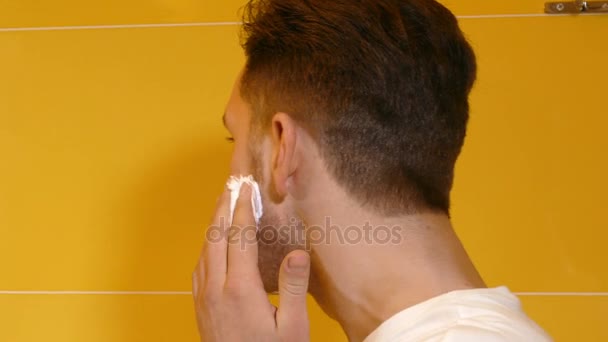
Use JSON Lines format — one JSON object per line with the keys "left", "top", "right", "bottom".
{"left": 277, "top": 250, "right": 310, "bottom": 341}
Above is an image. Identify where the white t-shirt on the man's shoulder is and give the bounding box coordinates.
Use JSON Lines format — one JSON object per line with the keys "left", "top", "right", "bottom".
{"left": 364, "top": 286, "right": 552, "bottom": 342}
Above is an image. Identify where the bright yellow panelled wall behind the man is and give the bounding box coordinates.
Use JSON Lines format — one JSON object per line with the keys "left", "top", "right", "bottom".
{"left": 0, "top": 0, "right": 608, "bottom": 342}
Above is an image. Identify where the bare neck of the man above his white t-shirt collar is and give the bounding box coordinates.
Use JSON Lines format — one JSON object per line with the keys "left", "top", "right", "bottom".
{"left": 307, "top": 212, "right": 485, "bottom": 341}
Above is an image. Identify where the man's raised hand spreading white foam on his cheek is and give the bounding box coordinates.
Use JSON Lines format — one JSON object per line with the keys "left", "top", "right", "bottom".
{"left": 192, "top": 184, "right": 310, "bottom": 342}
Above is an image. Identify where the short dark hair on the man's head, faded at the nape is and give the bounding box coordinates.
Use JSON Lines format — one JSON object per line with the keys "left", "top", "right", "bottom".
{"left": 240, "top": 0, "right": 476, "bottom": 215}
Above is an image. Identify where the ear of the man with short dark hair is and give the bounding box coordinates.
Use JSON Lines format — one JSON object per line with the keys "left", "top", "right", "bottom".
{"left": 271, "top": 113, "right": 298, "bottom": 198}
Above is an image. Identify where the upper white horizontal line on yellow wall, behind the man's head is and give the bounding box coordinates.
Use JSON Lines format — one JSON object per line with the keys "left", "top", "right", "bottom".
{"left": 0, "top": 13, "right": 606, "bottom": 32}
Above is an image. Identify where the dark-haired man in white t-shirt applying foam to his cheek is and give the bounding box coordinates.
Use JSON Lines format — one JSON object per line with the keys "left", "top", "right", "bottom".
{"left": 193, "top": 0, "right": 549, "bottom": 342}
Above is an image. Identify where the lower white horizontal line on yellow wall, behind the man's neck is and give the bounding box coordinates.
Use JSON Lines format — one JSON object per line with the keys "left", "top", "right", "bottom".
{"left": 0, "top": 291, "right": 608, "bottom": 297}
